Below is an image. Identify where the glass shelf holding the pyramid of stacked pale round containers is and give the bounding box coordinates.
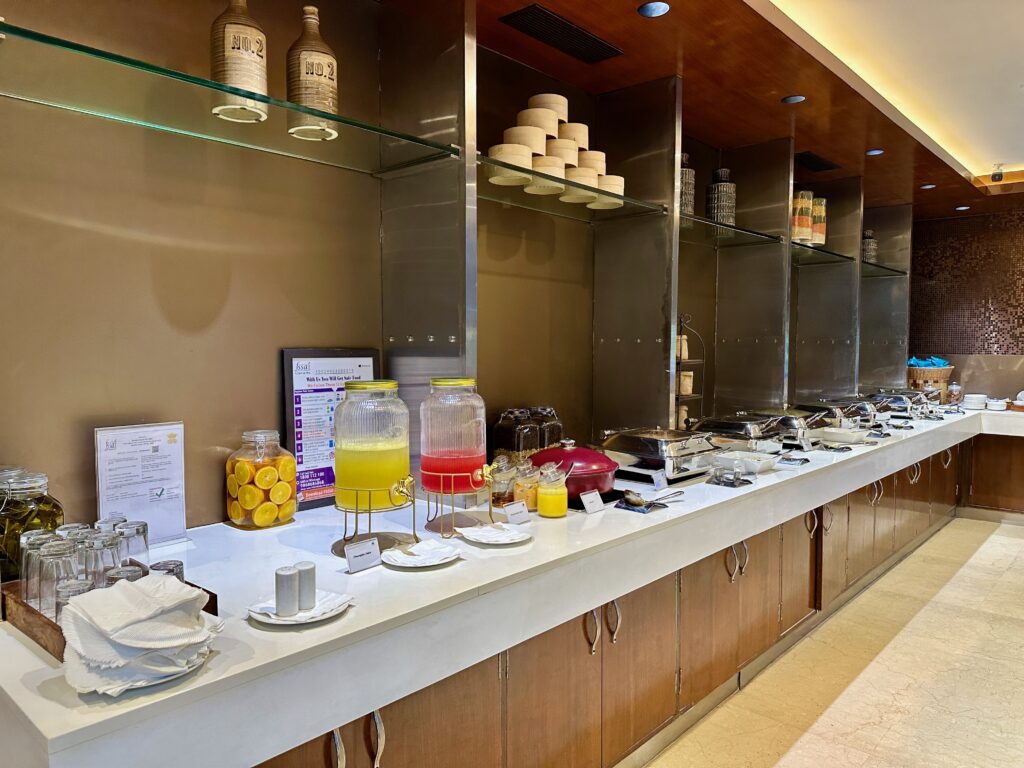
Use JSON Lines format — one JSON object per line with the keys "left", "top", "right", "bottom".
{"left": 476, "top": 155, "right": 666, "bottom": 221}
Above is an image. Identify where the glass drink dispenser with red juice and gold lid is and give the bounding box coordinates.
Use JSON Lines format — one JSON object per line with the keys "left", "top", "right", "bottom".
{"left": 420, "top": 378, "right": 487, "bottom": 494}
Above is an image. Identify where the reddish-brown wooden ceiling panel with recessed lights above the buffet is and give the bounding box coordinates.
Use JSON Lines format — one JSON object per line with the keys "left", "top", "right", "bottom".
{"left": 477, "top": 0, "right": 1024, "bottom": 219}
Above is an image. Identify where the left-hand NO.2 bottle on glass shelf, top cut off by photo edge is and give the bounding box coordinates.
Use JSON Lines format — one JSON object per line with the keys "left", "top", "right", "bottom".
{"left": 210, "top": 0, "right": 267, "bottom": 123}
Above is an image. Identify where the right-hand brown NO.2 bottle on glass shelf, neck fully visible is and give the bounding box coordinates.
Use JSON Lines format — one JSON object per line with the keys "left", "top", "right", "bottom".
{"left": 288, "top": 5, "right": 338, "bottom": 141}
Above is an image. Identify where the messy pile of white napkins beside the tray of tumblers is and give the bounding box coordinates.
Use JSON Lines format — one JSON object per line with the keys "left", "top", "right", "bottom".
{"left": 60, "top": 574, "right": 223, "bottom": 696}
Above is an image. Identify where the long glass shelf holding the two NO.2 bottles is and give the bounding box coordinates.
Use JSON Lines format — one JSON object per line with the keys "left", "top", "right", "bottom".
{"left": 0, "top": 23, "right": 459, "bottom": 175}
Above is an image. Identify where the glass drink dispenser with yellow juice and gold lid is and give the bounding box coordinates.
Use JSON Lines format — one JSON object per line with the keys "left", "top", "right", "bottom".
{"left": 334, "top": 380, "right": 409, "bottom": 512}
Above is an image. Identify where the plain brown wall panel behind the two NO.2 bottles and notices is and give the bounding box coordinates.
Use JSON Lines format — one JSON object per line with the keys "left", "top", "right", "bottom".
{"left": 0, "top": 0, "right": 381, "bottom": 525}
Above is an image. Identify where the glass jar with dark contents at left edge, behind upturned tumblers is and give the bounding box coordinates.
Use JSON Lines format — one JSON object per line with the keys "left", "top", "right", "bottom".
{"left": 0, "top": 470, "right": 63, "bottom": 582}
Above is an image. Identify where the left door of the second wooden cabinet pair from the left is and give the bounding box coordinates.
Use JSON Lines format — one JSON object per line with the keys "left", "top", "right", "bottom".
{"left": 507, "top": 610, "right": 603, "bottom": 768}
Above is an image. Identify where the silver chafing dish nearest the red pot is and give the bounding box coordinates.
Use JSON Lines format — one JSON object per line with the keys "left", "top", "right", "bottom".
{"left": 601, "top": 429, "right": 717, "bottom": 482}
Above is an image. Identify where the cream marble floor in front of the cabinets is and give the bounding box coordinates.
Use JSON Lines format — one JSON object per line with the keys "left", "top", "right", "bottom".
{"left": 650, "top": 519, "right": 1024, "bottom": 768}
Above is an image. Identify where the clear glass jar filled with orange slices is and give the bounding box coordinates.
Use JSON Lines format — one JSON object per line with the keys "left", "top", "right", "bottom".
{"left": 225, "top": 429, "right": 296, "bottom": 529}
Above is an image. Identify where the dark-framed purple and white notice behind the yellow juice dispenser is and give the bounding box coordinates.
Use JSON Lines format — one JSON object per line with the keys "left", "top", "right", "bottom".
{"left": 281, "top": 348, "right": 380, "bottom": 509}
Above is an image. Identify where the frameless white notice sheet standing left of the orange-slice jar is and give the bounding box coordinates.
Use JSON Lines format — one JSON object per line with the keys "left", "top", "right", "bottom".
{"left": 95, "top": 421, "right": 185, "bottom": 544}
